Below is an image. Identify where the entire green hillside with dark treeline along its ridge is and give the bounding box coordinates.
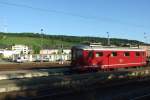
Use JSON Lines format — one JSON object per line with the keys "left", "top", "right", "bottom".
{"left": 0, "top": 33, "right": 144, "bottom": 52}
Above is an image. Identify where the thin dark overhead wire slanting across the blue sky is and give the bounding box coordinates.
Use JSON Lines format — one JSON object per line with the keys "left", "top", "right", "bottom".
{"left": 0, "top": 1, "right": 149, "bottom": 29}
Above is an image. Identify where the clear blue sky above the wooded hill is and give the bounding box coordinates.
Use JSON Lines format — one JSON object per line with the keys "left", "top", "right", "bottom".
{"left": 0, "top": 0, "right": 150, "bottom": 43}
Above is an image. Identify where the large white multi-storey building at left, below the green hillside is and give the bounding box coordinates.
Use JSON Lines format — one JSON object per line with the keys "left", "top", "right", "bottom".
{"left": 12, "top": 45, "right": 31, "bottom": 54}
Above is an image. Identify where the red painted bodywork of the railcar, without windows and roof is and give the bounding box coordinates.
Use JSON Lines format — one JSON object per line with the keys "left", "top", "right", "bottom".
{"left": 72, "top": 45, "right": 146, "bottom": 69}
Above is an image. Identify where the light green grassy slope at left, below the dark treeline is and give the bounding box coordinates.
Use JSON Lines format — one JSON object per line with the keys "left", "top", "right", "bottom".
{"left": 0, "top": 36, "right": 72, "bottom": 47}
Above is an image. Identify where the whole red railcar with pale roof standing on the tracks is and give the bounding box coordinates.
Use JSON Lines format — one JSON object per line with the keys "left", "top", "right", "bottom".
{"left": 71, "top": 45, "right": 146, "bottom": 70}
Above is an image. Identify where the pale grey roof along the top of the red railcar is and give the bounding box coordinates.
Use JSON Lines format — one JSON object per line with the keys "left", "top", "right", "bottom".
{"left": 73, "top": 45, "right": 145, "bottom": 51}
